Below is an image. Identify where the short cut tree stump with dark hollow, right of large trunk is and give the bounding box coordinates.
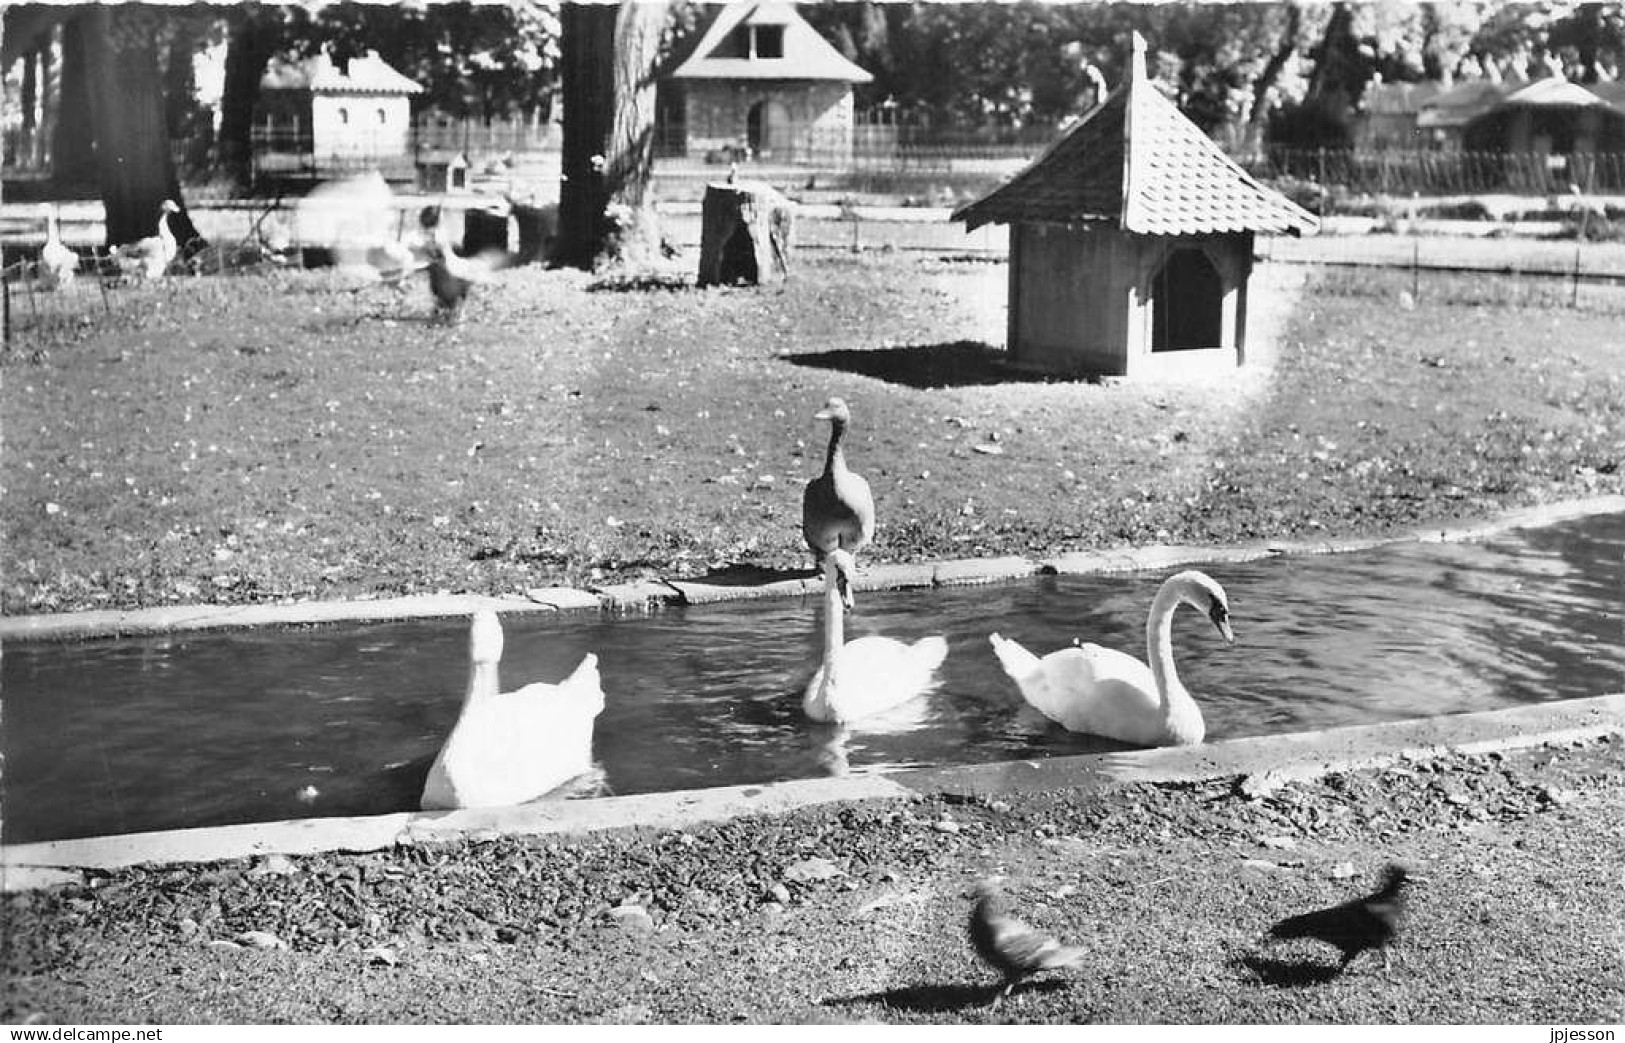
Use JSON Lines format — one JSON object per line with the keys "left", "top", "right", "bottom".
{"left": 699, "top": 182, "right": 795, "bottom": 286}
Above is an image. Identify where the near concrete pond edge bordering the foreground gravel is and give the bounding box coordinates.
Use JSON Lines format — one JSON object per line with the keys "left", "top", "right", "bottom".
{"left": 0, "top": 692, "right": 1625, "bottom": 892}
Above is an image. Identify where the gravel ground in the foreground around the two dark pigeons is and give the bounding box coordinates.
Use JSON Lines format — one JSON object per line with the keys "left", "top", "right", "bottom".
{"left": 0, "top": 736, "right": 1625, "bottom": 1024}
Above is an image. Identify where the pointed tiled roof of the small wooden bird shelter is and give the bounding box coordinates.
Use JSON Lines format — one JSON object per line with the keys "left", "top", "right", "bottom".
{"left": 954, "top": 32, "right": 1320, "bottom": 236}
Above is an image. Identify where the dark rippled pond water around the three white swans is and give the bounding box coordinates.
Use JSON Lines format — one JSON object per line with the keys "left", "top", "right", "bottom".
{"left": 0, "top": 515, "right": 1625, "bottom": 843}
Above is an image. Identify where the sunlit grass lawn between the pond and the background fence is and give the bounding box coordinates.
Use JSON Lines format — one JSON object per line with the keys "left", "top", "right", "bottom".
{"left": 0, "top": 252, "right": 1625, "bottom": 614}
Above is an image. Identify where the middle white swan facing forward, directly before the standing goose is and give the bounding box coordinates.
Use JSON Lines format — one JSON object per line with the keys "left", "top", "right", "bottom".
{"left": 801, "top": 547, "right": 947, "bottom": 723}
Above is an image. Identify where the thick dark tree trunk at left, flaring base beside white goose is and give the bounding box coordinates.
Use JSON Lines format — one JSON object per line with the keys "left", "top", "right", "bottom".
{"left": 80, "top": 5, "right": 203, "bottom": 252}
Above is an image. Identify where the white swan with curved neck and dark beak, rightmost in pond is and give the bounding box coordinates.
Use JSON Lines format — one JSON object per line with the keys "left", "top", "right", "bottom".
{"left": 988, "top": 570, "right": 1235, "bottom": 746}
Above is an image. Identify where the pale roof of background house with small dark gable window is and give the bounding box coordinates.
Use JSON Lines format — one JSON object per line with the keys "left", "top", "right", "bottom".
{"left": 671, "top": 0, "right": 874, "bottom": 83}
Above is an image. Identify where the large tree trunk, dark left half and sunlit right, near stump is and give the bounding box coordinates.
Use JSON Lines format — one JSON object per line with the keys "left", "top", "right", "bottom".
{"left": 554, "top": 0, "right": 666, "bottom": 268}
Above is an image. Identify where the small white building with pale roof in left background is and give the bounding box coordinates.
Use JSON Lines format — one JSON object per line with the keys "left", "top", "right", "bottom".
{"left": 254, "top": 50, "right": 423, "bottom": 180}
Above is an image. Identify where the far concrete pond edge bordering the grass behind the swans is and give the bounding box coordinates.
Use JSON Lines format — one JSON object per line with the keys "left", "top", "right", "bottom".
{"left": 0, "top": 496, "right": 1625, "bottom": 642}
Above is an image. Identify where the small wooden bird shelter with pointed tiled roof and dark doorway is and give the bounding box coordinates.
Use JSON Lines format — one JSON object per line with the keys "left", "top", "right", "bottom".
{"left": 954, "top": 32, "right": 1320, "bottom": 377}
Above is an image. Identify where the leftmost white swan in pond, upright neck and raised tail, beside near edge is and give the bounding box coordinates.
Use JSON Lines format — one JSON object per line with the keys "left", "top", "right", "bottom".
{"left": 419, "top": 611, "right": 605, "bottom": 811}
